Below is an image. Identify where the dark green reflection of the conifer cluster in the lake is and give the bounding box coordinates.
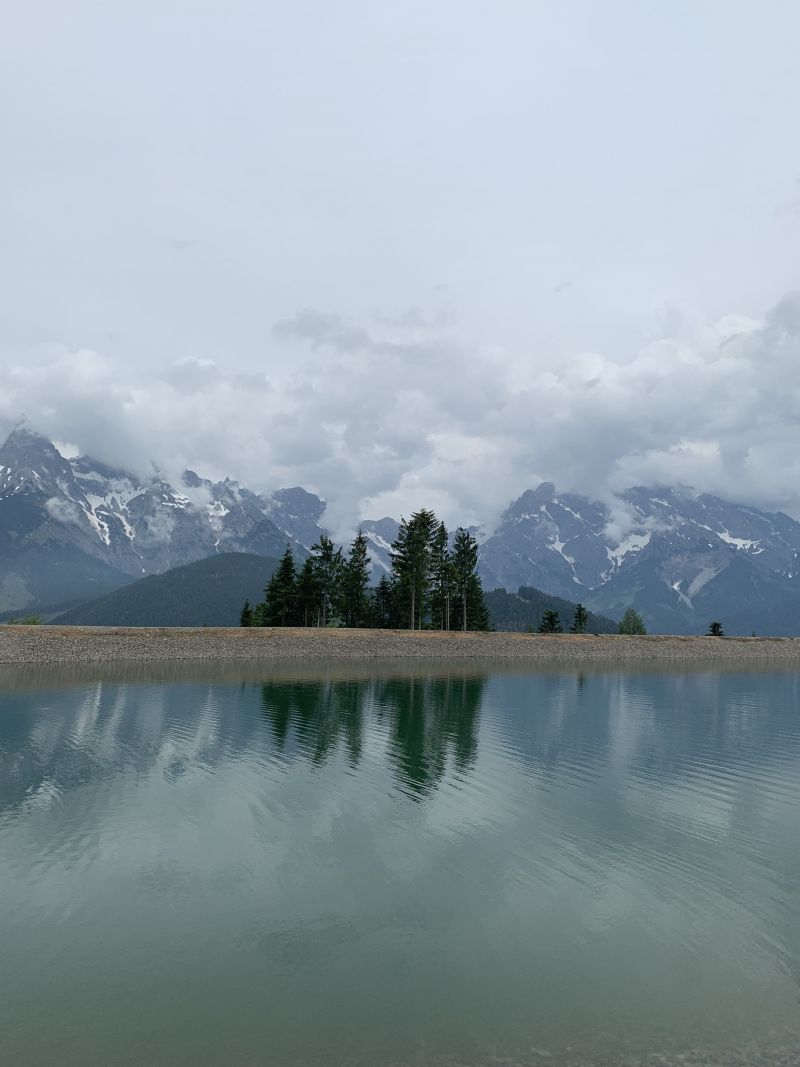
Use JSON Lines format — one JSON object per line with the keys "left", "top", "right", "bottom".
{"left": 261, "top": 676, "right": 485, "bottom": 795}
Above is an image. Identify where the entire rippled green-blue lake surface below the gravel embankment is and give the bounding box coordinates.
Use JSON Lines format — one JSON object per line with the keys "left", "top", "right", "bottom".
{"left": 0, "top": 664, "right": 800, "bottom": 1067}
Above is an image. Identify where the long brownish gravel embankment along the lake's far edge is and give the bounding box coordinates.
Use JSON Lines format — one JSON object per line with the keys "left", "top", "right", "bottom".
{"left": 0, "top": 626, "right": 800, "bottom": 665}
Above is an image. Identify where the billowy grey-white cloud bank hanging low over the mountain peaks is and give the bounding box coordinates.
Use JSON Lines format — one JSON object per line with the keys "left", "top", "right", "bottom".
{"left": 0, "top": 293, "right": 800, "bottom": 537}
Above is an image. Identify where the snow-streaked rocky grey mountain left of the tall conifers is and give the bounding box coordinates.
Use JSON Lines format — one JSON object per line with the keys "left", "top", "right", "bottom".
{"left": 0, "top": 425, "right": 324, "bottom": 611}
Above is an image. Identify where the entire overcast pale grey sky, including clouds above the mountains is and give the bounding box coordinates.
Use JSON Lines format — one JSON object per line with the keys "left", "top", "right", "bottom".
{"left": 0, "top": 0, "right": 800, "bottom": 532}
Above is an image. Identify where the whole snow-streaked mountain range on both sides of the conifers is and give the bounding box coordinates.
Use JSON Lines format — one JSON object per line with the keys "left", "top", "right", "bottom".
{"left": 0, "top": 424, "right": 800, "bottom": 635}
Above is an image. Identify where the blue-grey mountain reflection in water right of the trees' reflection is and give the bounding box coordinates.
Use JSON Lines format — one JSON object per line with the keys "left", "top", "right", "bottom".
{"left": 499, "top": 670, "right": 800, "bottom": 780}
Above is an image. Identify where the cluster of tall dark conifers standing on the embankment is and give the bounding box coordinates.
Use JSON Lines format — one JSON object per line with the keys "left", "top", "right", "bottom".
{"left": 241, "top": 509, "right": 490, "bottom": 630}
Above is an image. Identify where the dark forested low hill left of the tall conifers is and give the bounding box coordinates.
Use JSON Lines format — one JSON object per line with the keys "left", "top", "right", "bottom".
{"left": 51, "top": 553, "right": 277, "bottom": 626}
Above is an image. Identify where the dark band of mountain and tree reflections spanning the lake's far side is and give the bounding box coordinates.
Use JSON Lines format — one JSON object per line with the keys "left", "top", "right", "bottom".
{"left": 0, "top": 670, "right": 800, "bottom": 812}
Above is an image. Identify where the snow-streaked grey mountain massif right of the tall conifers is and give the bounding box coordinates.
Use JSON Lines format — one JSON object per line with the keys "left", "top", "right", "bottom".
{"left": 481, "top": 482, "right": 800, "bottom": 634}
